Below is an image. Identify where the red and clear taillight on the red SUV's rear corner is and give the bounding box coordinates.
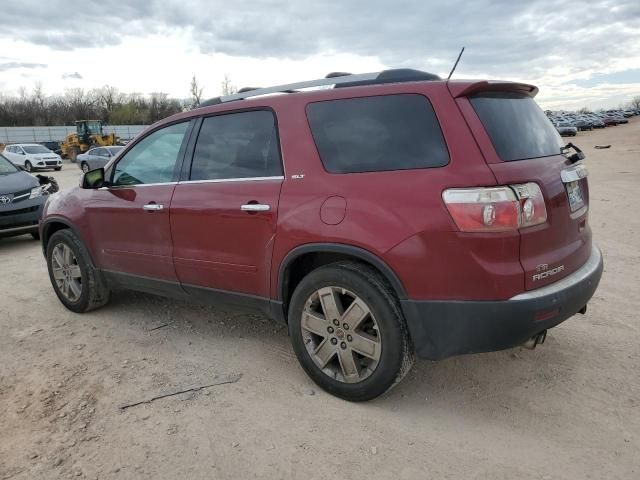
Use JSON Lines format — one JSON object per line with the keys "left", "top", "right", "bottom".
{"left": 442, "top": 183, "right": 547, "bottom": 232}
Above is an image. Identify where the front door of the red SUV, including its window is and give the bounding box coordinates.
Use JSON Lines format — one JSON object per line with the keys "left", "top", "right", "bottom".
{"left": 87, "top": 122, "right": 189, "bottom": 283}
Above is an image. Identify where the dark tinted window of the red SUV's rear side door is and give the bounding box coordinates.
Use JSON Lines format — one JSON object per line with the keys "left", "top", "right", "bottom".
{"left": 190, "top": 110, "right": 282, "bottom": 180}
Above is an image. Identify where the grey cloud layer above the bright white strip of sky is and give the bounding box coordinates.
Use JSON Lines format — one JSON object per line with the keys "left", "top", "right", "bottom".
{"left": 0, "top": 0, "right": 640, "bottom": 108}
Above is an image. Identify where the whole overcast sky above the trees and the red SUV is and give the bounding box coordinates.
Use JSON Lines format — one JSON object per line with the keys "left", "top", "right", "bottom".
{"left": 0, "top": 0, "right": 640, "bottom": 108}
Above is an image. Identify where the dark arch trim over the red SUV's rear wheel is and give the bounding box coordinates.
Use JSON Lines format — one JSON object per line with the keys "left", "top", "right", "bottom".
{"left": 277, "top": 243, "right": 407, "bottom": 320}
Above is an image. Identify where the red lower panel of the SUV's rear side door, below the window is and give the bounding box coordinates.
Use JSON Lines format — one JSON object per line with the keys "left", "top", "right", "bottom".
{"left": 171, "top": 180, "right": 282, "bottom": 297}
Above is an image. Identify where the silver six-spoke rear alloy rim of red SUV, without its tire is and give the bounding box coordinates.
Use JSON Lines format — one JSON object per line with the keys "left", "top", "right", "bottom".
{"left": 300, "top": 286, "right": 382, "bottom": 383}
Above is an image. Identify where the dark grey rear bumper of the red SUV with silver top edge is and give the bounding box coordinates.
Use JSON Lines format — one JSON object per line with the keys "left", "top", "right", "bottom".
{"left": 401, "top": 246, "right": 603, "bottom": 360}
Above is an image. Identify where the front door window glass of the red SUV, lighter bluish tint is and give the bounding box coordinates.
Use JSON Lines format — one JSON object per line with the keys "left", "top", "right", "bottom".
{"left": 111, "top": 121, "right": 189, "bottom": 186}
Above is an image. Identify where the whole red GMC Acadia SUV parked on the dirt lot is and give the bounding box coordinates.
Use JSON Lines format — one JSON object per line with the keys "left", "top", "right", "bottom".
{"left": 40, "top": 70, "right": 603, "bottom": 400}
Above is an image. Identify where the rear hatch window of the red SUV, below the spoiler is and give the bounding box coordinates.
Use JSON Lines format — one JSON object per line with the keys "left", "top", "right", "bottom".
{"left": 469, "top": 92, "right": 564, "bottom": 162}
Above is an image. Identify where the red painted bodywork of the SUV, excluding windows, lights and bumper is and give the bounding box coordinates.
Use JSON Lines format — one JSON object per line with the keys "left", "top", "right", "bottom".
{"left": 45, "top": 82, "right": 591, "bottom": 300}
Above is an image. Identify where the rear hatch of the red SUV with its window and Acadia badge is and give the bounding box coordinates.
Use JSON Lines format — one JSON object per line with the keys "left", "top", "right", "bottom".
{"left": 457, "top": 82, "right": 591, "bottom": 290}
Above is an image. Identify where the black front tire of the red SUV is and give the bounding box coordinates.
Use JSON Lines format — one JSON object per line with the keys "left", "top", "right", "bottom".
{"left": 47, "top": 229, "right": 110, "bottom": 313}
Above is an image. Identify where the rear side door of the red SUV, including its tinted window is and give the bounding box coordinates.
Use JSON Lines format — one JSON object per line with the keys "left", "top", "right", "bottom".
{"left": 171, "top": 110, "right": 284, "bottom": 297}
